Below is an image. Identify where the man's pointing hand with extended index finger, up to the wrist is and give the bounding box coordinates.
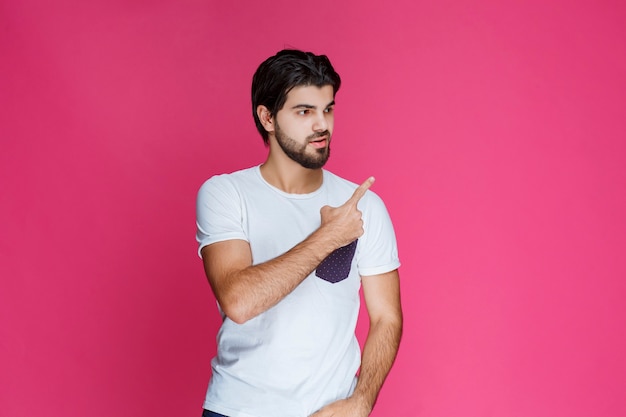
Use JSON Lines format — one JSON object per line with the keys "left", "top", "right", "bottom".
{"left": 320, "top": 177, "right": 374, "bottom": 248}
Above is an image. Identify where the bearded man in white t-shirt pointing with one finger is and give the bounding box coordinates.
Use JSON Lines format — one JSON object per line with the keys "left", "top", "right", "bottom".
{"left": 197, "top": 50, "right": 402, "bottom": 417}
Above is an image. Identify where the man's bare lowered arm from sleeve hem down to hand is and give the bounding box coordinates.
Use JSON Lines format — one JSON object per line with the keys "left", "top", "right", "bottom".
{"left": 311, "top": 270, "right": 402, "bottom": 417}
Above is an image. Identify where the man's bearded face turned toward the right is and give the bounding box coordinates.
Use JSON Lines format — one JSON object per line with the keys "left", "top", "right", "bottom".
{"left": 273, "top": 85, "right": 335, "bottom": 169}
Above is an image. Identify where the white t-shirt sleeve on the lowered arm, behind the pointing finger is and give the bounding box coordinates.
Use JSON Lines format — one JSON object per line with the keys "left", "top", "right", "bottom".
{"left": 358, "top": 191, "right": 400, "bottom": 276}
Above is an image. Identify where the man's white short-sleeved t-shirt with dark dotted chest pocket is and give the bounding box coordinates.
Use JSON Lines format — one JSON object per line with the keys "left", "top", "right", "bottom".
{"left": 196, "top": 166, "right": 400, "bottom": 417}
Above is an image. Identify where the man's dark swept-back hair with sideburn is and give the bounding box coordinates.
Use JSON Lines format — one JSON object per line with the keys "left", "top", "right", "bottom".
{"left": 252, "top": 49, "right": 341, "bottom": 145}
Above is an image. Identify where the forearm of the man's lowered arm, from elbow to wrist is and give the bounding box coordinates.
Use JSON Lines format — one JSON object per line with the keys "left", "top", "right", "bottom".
{"left": 352, "top": 315, "right": 402, "bottom": 413}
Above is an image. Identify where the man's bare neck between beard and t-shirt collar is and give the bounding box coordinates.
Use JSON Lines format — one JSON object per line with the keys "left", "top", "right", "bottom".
{"left": 261, "top": 150, "right": 324, "bottom": 194}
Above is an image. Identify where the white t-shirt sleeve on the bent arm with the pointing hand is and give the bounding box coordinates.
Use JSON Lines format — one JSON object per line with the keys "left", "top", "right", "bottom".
{"left": 196, "top": 176, "right": 248, "bottom": 256}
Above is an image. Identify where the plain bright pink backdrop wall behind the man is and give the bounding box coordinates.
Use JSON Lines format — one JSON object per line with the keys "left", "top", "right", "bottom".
{"left": 0, "top": 0, "right": 626, "bottom": 417}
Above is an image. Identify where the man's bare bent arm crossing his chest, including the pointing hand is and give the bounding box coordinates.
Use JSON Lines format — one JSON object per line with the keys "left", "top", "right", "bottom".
{"left": 201, "top": 178, "right": 374, "bottom": 324}
